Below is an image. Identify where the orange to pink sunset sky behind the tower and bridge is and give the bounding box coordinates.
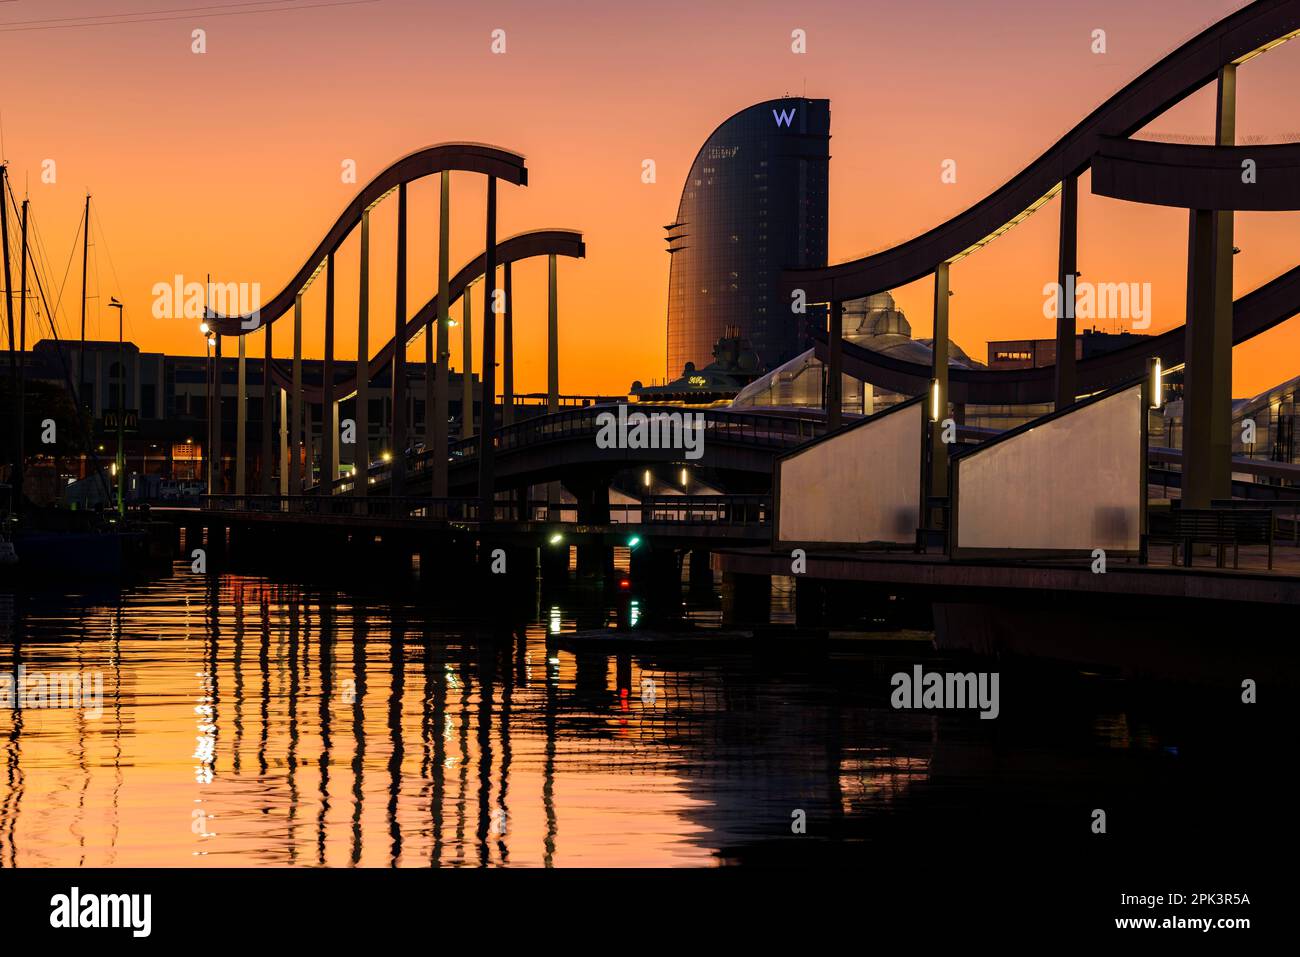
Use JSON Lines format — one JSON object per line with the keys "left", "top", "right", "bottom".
{"left": 0, "top": 0, "right": 1300, "bottom": 395}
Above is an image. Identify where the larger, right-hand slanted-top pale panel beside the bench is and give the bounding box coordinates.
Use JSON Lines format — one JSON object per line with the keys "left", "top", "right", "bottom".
{"left": 953, "top": 385, "right": 1147, "bottom": 553}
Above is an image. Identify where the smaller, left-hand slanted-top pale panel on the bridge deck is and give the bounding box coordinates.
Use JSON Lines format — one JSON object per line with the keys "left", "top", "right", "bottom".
{"left": 776, "top": 402, "right": 926, "bottom": 545}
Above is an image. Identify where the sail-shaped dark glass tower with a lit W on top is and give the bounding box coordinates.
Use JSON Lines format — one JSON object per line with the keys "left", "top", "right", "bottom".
{"left": 664, "top": 96, "right": 831, "bottom": 377}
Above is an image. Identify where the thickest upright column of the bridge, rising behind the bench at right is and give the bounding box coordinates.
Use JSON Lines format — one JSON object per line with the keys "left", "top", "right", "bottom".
{"left": 1183, "top": 64, "right": 1236, "bottom": 508}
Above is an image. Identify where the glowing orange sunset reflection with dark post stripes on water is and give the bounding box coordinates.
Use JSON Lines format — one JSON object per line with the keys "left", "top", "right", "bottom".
{"left": 0, "top": 566, "right": 889, "bottom": 866}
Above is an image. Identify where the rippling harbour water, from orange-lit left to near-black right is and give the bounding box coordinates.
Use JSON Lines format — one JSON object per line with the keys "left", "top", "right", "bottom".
{"left": 0, "top": 566, "right": 1294, "bottom": 871}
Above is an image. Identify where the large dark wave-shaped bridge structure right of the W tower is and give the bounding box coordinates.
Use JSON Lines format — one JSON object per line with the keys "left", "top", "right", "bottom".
{"left": 781, "top": 0, "right": 1300, "bottom": 507}
